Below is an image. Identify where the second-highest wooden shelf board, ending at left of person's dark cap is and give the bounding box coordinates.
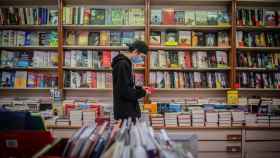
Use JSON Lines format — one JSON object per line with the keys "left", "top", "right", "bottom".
{"left": 63, "top": 45, "right": 128, "bottom": 50}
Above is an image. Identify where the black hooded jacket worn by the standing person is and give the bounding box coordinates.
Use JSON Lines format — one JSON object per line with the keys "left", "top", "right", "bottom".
{"left": 112, "top": 54, "right": 146, "bottom": 120}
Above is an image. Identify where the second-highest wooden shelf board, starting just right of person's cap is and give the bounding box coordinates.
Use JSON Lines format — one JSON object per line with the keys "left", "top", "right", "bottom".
{"left": 149, "top": 45, "right": 231, "bottom": 51}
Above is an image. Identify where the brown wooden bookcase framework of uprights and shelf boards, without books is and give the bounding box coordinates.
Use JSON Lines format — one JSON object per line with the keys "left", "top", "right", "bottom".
{"left": 0, "top": 0, "right": 280, "bottom": 99}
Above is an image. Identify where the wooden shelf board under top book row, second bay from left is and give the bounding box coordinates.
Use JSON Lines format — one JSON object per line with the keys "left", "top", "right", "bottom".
{"left": 63, "top": 24, "right": 145, "bottom": 30}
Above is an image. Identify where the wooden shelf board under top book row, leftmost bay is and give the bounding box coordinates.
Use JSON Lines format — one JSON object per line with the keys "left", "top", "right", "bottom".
{"left": 0, "top": 24, "right": 57, "bottom": 30}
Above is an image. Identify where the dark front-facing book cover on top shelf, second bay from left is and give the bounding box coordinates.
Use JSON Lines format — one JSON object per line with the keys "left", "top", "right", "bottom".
{"left": 90, "top": 8, "right": 105, "bottom": 25}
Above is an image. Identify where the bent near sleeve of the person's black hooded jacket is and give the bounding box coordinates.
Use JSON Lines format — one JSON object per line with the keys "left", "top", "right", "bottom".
{"left": 118, "top": 63, "right": 146, "bottom": 101}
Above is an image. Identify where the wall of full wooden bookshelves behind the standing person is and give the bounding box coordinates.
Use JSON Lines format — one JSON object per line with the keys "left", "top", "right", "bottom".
{"left": 0, "top": 0, "right": 280, "bottom": 97}
